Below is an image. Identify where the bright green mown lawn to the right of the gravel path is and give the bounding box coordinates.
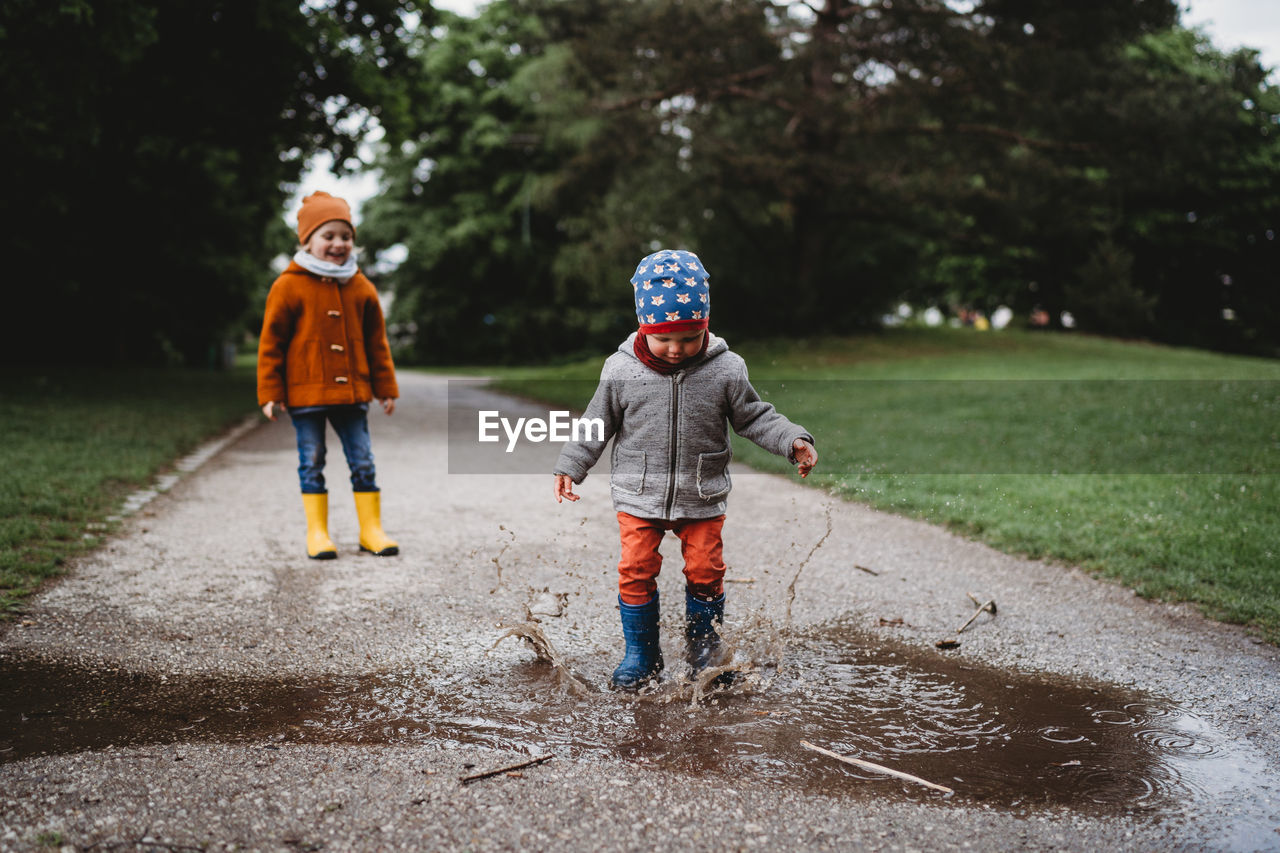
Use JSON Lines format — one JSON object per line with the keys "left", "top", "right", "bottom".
{"left": 486, "top": 329, "right": 1280, "bottom": 643}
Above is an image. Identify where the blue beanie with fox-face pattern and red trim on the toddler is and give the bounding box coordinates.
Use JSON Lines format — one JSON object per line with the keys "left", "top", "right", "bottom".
{"left": 631, "top": 248, "right": 712, "bottom": 334}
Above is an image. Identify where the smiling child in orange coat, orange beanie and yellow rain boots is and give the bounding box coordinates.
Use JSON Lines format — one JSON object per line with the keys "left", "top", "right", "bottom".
{"left": 257, "top": 192, "right": 399, "bottom": 560}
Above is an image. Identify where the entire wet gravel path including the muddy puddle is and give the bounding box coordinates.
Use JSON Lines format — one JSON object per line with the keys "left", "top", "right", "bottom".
{"left": 0, "top": 374, "right": 1280, "bottom": 850}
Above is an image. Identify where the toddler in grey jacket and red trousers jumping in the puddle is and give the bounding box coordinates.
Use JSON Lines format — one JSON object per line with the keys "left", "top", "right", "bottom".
{"left": 554, "top": 250, "right": 818, "bottom": 690}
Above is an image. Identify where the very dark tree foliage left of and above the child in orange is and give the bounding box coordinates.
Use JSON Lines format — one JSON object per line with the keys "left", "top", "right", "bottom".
{"left": 0, "top": 0, "right": 415, "bottom": 365}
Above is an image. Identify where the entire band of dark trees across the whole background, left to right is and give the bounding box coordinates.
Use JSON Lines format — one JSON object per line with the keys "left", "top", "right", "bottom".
{"left": 0, "top": 0, "right": 1280, "bottom": 364}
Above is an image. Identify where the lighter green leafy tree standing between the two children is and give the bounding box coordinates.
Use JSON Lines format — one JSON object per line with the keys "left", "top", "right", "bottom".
{"left": 362, "top": 3, "right": 604, "bottom": 362}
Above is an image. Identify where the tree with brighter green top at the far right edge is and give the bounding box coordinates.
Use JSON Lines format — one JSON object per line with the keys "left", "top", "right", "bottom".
{"left": 1100, "top": 29, "right": 1280, "bottom": 355}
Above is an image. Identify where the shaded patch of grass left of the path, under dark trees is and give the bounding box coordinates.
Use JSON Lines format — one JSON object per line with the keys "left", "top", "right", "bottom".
{"left": 0, "top": 368, "right": 256, "bottom": 617}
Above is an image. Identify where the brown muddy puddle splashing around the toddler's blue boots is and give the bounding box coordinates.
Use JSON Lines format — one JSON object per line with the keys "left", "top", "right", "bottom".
{"left": 0, "top": 624, "right": 1275, "bottom": 813}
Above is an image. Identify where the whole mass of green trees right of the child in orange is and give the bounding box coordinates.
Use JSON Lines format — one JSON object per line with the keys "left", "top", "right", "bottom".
{"left": 374, "top": 0, "right": 1280, "bottom": 362}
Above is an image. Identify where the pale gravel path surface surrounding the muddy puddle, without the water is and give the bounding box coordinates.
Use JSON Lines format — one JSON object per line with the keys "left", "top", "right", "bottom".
{"left": 0, "top": 371, "right": 1280, "bottom": 850}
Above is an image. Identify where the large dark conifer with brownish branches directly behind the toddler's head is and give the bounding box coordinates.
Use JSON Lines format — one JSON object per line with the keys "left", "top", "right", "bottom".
{"left": 519, "top": 0, "right": 918, "bottom": 334}
